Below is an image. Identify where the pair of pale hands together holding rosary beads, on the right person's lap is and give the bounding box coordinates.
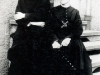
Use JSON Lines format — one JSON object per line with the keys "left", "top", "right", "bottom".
{"left": 52, "top": 38, "right": 71, "bottom": 49}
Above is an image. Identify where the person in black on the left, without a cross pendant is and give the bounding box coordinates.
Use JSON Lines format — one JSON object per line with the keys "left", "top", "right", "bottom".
{"left": 8, "top": 0, "right": 53, "bottom": 75}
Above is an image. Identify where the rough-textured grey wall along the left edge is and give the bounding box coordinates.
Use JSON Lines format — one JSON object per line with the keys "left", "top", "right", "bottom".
{"left": 0, "top": 0, "right": 17, "bottom": 75}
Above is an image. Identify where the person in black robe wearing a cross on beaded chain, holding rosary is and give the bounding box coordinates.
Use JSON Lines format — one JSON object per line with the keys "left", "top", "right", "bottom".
{"left": 50, "top": 0, "right": 92, "bottom": 75}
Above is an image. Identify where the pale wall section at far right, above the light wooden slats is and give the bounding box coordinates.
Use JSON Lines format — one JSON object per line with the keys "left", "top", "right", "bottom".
{"left": 91, "top": 0, "right": 100, "bottom": 30}
